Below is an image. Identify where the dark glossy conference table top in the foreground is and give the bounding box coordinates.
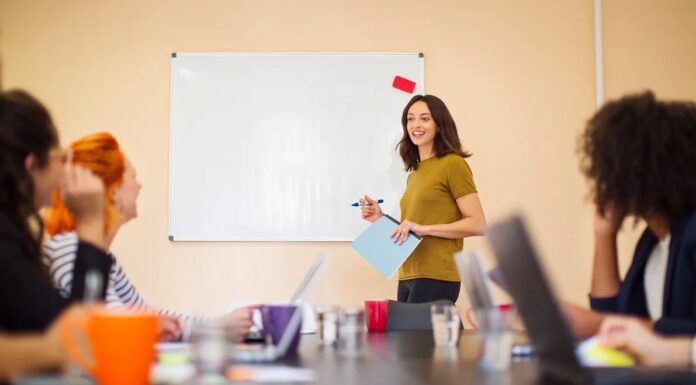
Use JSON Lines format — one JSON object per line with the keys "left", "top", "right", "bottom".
{"left": 14, "top": 330, "right": 538, "bottom": 385}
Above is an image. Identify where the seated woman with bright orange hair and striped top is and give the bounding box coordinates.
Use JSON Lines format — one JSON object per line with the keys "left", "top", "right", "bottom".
{"left": 43, "top": 133, "right": 251, "bottom": 340}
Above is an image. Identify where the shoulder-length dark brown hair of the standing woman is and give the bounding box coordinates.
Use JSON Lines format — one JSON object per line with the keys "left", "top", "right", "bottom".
{"left": 396, "top": 95, "right": 471, "bottom": 171}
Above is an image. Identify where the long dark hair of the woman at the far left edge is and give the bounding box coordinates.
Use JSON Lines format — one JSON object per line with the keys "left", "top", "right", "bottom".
{"left": 0, "top": 90, "right": 58, "bottom": 268}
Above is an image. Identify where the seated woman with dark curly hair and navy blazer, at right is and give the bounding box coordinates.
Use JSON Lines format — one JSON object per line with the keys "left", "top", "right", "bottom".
{"left": 566, "top": 92, "right": 696, "bottom": 335}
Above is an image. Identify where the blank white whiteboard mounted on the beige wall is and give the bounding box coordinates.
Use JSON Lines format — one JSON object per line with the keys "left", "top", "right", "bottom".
{"left": 169, "top": 53, "right": 424, "bottom": 241}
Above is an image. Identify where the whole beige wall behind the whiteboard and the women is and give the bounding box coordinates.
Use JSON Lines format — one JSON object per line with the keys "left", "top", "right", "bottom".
{"left": 0, "top": 0, "right": 696, "bottom": 314}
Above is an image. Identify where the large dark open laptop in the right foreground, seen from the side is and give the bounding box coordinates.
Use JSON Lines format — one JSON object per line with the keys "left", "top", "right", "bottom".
{"left": 488, "top": 216, "right": 696, "bottom": 384}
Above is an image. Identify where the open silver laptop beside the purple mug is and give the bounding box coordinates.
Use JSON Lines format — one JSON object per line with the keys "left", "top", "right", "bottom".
{"left": 231, "top": 255, "right": 328, "bottom": 362}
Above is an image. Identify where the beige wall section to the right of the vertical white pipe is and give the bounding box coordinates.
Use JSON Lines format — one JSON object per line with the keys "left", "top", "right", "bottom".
{"left": 603, "top": 0, "right": 696, "bottom": 284}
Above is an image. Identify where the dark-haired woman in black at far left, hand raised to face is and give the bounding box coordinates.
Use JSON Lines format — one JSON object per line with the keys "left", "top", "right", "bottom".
{"left": 0, "top": 91, "right": 111, "bottom": 332}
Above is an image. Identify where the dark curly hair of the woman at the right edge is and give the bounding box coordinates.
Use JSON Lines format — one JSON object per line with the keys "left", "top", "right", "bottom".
{"left": 581, "top": 91, "right": 696, "bottom": 222}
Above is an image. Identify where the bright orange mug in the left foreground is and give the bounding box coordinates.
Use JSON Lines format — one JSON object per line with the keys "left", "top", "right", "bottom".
{"left": 59, "top": 307, "right": 159, "bottom": 385}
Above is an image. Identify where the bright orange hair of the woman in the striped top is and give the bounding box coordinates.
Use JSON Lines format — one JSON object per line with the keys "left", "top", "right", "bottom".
{"left": 44, "top": 132, "right": 126, "bottom": 236}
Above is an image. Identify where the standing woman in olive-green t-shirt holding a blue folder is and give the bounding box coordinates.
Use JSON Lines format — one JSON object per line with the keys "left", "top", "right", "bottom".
{"left": 361, "top": 95, "right": 486, "bottom": 303}
